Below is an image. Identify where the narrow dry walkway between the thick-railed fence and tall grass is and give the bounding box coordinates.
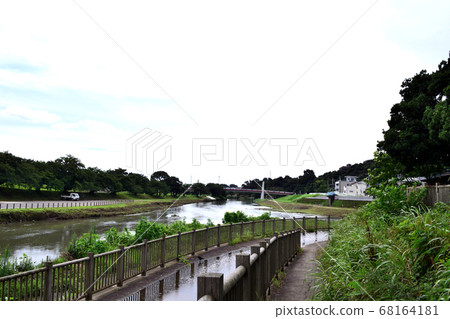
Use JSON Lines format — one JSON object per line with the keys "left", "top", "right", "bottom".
{"left": 270, "top": 242, "right": 327, "bottom": 301}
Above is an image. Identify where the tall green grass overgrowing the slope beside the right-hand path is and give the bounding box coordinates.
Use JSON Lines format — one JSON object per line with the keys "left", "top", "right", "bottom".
{"left": 315, "top": 202, "right": 450, "bottom": 300}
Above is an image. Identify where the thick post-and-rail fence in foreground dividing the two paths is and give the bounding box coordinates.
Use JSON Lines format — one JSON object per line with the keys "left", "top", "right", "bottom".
{"left": 197, "top": 229, "right": 301, "bottom": 301}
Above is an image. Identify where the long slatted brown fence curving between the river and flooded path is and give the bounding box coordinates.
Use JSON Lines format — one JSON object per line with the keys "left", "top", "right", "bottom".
{"left": 0, "top": 216, "right": 332, "bottom": 301}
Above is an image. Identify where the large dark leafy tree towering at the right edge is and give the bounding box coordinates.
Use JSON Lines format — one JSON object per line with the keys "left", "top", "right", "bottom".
{"left": 377, "top": 58, "right": 450, "bottom": 177}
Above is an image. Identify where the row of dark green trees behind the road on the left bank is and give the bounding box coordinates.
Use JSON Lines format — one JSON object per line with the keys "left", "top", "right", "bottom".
{"left": 0, "top": 152, "right": 225, "bottom": 197}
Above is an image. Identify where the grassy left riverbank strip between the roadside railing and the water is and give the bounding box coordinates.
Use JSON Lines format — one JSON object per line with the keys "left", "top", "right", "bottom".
{"left": 0, "top": 198, "right": 211, "bottom": 224}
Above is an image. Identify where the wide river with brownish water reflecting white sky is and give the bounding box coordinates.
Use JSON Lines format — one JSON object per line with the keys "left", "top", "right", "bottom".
{"left": 0, "top": 200, "right": 311, "bottom": 262}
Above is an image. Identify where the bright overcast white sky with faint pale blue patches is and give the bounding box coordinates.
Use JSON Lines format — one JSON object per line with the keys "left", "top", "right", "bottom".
{"left": 0, "top": 0, "right": 450, "bottom": 184}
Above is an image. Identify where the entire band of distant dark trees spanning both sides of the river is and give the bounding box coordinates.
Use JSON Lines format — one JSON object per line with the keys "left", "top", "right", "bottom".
{"left": 0, "top": 152, "right": 374, "bottom": 198}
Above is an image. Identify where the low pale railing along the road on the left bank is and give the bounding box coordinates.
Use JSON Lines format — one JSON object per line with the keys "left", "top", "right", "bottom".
{"left": 0, "top": 199, "right": 134, "bottom": 209}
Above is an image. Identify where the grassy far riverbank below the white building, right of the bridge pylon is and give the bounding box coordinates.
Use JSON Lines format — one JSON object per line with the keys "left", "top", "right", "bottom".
{"left": 255, "top": 197, "right": 356, "bottom": 217}
